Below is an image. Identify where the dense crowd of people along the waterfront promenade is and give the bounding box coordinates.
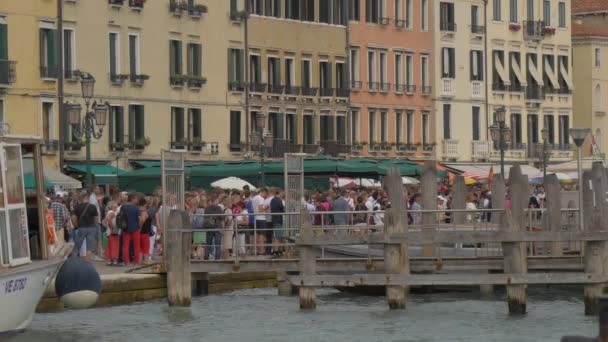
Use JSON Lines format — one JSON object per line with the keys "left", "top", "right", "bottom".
{"left": 49, "top": 180, "right": 546, "bottom": 266}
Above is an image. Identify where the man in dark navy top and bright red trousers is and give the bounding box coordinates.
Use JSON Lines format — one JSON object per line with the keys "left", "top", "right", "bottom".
{"left": 120, "top": 194, "right": 146, "bottom": 266}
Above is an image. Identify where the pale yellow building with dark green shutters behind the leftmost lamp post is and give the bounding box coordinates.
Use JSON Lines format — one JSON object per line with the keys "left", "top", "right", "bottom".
{"left": 63, "top": 0, "right": 245, "bottom": 168}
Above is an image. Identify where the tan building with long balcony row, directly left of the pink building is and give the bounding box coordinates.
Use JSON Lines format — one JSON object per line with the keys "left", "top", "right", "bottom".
{"left": 242, "top": 0, "right": 349, "bottom": 157}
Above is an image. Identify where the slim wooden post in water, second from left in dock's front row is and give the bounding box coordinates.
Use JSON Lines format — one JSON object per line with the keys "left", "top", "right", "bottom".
{"left": 298, "top": 209, "right": 317, "bottom": 309}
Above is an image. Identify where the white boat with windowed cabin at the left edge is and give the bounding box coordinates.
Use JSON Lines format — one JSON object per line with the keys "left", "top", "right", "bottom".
{"left": 0, "top": 136, "right": 71, "bottom": 336}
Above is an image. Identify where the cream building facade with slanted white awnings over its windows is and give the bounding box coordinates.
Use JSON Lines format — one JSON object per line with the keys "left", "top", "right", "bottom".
{"left": 485, "top": 0, "right": 574, "bottom": 164}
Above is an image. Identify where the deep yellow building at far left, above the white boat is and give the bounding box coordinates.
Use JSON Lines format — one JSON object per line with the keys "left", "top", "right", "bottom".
{"left": 0, "top": 0, "right": 59, "bottom": 166}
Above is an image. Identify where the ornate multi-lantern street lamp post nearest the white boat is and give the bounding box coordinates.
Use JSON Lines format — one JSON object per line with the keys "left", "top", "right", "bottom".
{"left": 66, "top": 73, "right": 109, "bottom": 193}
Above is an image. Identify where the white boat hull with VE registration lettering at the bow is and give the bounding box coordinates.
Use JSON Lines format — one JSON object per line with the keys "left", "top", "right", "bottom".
{"left": 0, "top": 259, "right": 65, "bottom": 335}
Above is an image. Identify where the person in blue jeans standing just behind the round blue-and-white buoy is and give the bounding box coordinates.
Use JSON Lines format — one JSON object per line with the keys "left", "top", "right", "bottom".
{"left": 72, "top": 192, "right": 99, "bottom": 261}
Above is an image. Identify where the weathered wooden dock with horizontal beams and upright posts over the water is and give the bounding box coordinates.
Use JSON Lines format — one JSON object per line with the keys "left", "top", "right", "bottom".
{"left": 166, "top": 162, "right": 608, "bottom": 314}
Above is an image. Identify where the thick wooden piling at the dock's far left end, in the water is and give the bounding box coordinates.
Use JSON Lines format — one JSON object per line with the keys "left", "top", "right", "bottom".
{"left": 165, "top": 210, "right": 192, "bottom": 306}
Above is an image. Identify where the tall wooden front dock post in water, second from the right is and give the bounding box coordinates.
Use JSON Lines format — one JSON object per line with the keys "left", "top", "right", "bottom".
{"left": 500, "top": 166, "right": 530, "bottom": 314}
